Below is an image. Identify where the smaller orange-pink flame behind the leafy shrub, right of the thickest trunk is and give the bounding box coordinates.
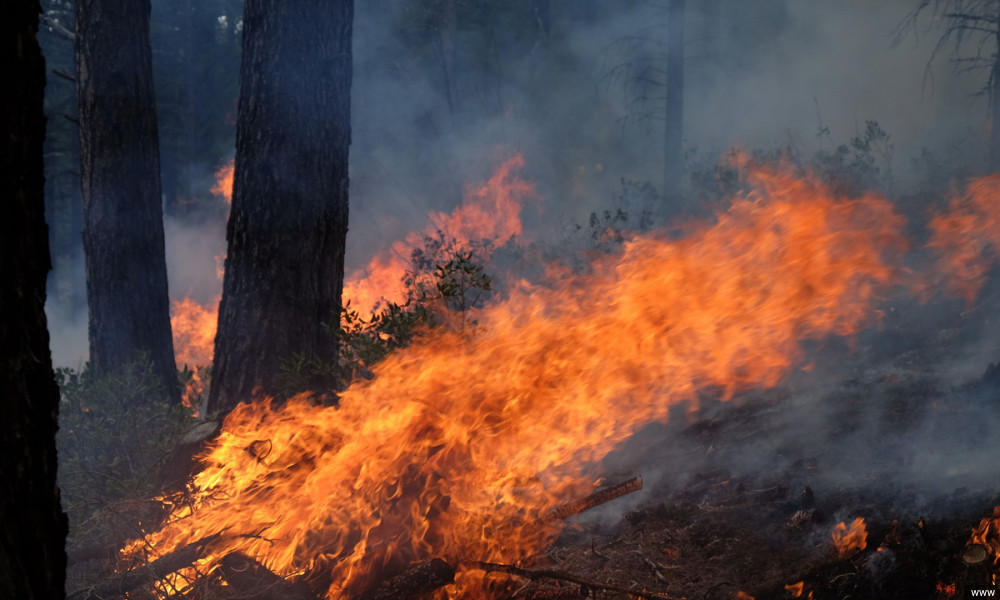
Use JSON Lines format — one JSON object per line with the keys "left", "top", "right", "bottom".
{"left": 344, "top": 154, "right": 537, "bottom": 315}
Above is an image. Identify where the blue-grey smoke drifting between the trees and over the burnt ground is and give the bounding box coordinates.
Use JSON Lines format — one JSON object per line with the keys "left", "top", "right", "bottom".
{"left": 47, "top": 0, "right": 1000, "bottom": 528}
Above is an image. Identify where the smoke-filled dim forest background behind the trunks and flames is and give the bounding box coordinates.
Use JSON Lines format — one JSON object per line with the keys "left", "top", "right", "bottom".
{"left": 39, "top": 0, "right": 995, "bottom": 368}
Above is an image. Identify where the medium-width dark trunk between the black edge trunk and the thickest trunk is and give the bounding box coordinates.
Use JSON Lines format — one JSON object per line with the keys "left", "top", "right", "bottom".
{"left": 76, "top": 0, "right": 180, "bottom": 402}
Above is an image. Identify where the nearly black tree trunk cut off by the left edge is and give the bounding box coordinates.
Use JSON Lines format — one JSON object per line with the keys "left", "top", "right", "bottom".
{"left": 0, "top": 0, "right": 66, "bottom": 600}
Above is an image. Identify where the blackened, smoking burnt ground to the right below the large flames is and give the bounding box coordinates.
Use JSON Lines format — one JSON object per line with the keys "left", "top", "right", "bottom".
{"left": 490, "top": 292, "right": 1000, "bottom": 600}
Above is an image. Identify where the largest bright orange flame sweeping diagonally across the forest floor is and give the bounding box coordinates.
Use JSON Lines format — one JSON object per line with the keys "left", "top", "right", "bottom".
{"left": 128, "top": 161, "right": 906, "bottom": 599}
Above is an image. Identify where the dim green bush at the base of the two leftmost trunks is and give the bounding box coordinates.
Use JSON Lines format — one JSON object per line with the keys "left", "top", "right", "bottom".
{"left": 56, "top": 356, "right": 192, "bottom": 547}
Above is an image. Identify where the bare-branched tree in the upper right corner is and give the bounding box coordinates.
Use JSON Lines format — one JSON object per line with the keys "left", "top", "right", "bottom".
{"left": 895, "top": 0, "right": 1000, "bottom": 171}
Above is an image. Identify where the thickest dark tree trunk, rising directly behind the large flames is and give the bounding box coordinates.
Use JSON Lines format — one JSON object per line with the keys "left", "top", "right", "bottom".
{"left": 208, "top": 0, "right": 354, "bottom": 412}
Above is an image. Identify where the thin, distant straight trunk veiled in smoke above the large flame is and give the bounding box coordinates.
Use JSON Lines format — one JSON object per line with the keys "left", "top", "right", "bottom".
{"left": 663, "top": 0, "right": 684, "bottom": 213}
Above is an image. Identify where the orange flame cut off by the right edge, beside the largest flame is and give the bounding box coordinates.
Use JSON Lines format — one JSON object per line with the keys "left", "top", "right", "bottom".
{"left": 928, "top": 174, "right": 1000, "bottom": 304}
